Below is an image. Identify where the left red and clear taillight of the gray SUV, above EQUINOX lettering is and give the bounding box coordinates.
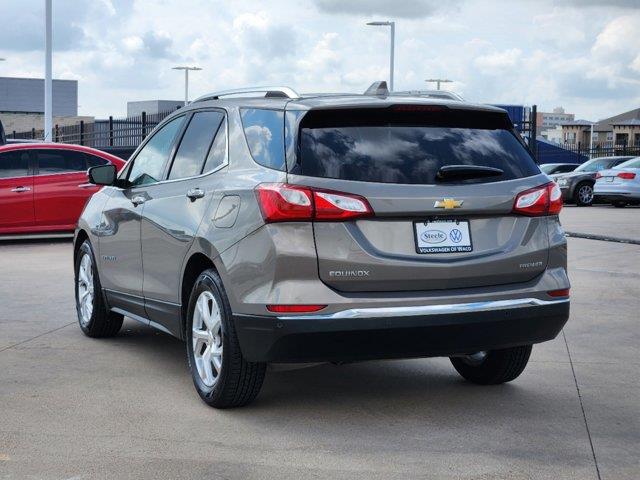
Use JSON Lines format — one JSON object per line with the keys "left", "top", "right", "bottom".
{"left": 256, "top": 183, "right": 373, "bottom": 223}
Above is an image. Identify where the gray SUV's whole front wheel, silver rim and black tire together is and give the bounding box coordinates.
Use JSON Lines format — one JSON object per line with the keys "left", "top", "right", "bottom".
{"left": 75, "top": 240, "right": 124, "bottom": 338}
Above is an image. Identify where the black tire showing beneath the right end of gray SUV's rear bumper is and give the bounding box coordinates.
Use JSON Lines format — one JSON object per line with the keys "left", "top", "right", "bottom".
{"left": 450, "top": 345, "right": 532, "bottom": 385}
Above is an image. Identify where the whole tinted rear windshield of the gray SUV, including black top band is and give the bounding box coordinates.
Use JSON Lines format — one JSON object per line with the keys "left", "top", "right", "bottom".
{"left": 295, "top": 105, "right": 540, "bottom": 184}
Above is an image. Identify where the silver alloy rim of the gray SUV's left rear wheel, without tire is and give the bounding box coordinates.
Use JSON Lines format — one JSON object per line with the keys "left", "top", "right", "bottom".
{"left": 191, "top": 291, "right": 223, "bottom": 387}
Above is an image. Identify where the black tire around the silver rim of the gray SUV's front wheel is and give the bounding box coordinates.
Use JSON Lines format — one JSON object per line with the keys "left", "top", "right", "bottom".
{"left": 74, "top": 240, "right": 124, "bottom": 338}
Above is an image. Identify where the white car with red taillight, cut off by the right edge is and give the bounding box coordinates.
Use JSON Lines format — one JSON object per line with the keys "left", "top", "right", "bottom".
{"left": 593, "top": 157, "right": 640, "bottom": 208}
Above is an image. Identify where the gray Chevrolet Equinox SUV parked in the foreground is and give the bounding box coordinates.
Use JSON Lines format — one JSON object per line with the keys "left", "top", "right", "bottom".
{"left": 74, "top": 83, "right": 569, "bottom": 408}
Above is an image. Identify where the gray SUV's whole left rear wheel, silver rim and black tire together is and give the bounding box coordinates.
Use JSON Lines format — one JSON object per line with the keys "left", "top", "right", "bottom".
{"left": 186, "top": 270, "right": 266, "bottom": 408}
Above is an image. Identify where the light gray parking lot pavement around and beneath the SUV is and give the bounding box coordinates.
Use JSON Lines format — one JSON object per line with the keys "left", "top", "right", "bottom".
{"left": 0, "top": 206, "right": 640, "bottom": 480}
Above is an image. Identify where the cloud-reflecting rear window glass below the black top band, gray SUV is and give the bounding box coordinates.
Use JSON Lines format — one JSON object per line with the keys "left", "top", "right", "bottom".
{"left": 300, "top": 125, "right": 538, "bottom": 184}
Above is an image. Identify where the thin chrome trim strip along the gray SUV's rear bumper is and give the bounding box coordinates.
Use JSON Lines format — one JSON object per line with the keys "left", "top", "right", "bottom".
{"left": 277, "top": 298, "right": 569, "bottom": 320}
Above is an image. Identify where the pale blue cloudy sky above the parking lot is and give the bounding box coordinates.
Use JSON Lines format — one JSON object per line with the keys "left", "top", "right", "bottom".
{"left": 0, "top": 0, "right": 640, "bottom": 119}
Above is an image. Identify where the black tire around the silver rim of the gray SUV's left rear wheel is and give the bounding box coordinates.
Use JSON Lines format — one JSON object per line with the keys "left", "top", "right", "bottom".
{"left": 185, "top": 270, "right": 266, "bottom": 408}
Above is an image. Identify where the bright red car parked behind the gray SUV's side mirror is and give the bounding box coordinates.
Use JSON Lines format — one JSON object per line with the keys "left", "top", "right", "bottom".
{"left": 0, "top": 143, "right": 125, "bottom": 235}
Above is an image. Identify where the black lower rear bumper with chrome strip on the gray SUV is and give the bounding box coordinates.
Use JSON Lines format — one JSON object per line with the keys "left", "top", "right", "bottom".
{"left": 234, "top": 298, "right": 569, "bottom": 362}
